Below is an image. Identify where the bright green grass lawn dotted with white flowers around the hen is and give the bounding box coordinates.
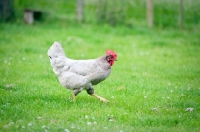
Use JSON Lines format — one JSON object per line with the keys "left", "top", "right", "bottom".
{"left": 0, "top": 24, "right": 200, "bottom": 132}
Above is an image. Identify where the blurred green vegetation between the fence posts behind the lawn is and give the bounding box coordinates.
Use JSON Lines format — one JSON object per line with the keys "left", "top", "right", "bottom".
{"left": 2, "top": 0, "right": 200, "bottom": 27}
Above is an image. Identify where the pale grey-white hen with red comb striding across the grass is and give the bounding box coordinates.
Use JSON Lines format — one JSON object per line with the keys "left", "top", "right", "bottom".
{"left": 47, "top": 42, "right": 117, "bottom": 102}
